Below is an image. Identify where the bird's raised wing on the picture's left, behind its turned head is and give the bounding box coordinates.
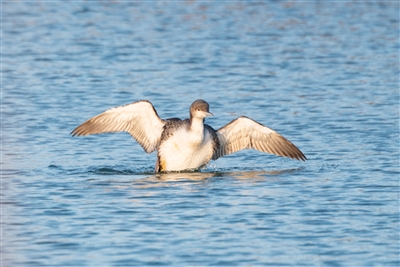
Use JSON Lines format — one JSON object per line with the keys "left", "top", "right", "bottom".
{"left": 71, "top": 100, "right": 165, "bottom": 153}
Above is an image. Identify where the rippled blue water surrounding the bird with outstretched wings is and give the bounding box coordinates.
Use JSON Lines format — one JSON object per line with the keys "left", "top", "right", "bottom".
{"left": 1, "top": 1, "right": 400, "bottom": 266}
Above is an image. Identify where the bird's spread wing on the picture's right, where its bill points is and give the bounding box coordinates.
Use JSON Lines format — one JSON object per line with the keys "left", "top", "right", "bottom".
{"left": 213, "top": 116, "right": 307, "bottom": 161}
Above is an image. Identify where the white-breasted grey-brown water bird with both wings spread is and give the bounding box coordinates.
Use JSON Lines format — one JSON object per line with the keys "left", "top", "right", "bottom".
{"left": 71, "top": 99, "right": 307, "bottom": 173}
